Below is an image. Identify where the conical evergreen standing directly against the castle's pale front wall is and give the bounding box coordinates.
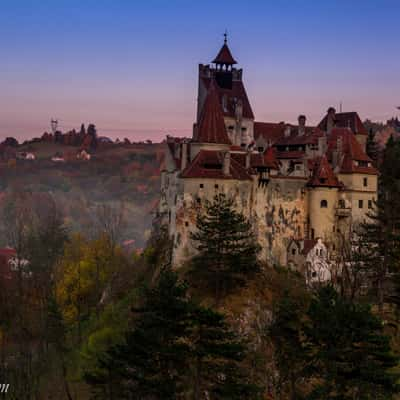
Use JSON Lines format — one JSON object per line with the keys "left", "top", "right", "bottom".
{"left": 191, "top": 194, "right": 259, "bottom": 303}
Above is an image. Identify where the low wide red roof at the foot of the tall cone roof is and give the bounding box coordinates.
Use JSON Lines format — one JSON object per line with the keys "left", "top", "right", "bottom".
{"left": 181, "top": 150, "right": 251, "bottom": 180}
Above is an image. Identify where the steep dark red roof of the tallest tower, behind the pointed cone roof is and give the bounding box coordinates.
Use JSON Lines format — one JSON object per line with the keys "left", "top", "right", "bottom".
{"left": 202, "top": 78, "right": 254, "bottom": 119}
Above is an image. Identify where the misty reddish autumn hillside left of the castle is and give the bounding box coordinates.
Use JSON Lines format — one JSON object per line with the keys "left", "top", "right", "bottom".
{"left": 0, "top": 142, "right": 163, "bottom": 247}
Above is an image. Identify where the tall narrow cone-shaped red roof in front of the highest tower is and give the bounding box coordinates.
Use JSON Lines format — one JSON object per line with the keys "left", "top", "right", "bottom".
{"left": 194, "top": 81, "right": 231, "bottom": 144}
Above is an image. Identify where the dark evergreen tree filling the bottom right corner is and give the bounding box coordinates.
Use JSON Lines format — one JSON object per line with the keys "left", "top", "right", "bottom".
{"left": 303, "top": 286, "right": 399, "bottom": 400}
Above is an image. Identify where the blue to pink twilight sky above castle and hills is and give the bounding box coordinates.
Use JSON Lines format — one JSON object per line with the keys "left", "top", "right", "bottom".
{"left": 0, "top": 0, "right": 400, "bottom": 140}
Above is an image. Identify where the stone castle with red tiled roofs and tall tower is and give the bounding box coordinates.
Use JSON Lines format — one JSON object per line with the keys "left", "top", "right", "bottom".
{"left": 159, "top": 37, "right": 377, "bottom": 265}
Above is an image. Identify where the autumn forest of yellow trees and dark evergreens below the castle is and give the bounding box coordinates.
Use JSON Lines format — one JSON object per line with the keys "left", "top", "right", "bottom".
{"left": 0, "top": 140, "right": 400, "bottom": 400}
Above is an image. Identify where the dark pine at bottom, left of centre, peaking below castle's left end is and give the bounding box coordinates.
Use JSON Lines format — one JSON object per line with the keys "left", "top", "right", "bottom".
{"left": 85, "top": 271, "right": 189, "bottom": 400}
